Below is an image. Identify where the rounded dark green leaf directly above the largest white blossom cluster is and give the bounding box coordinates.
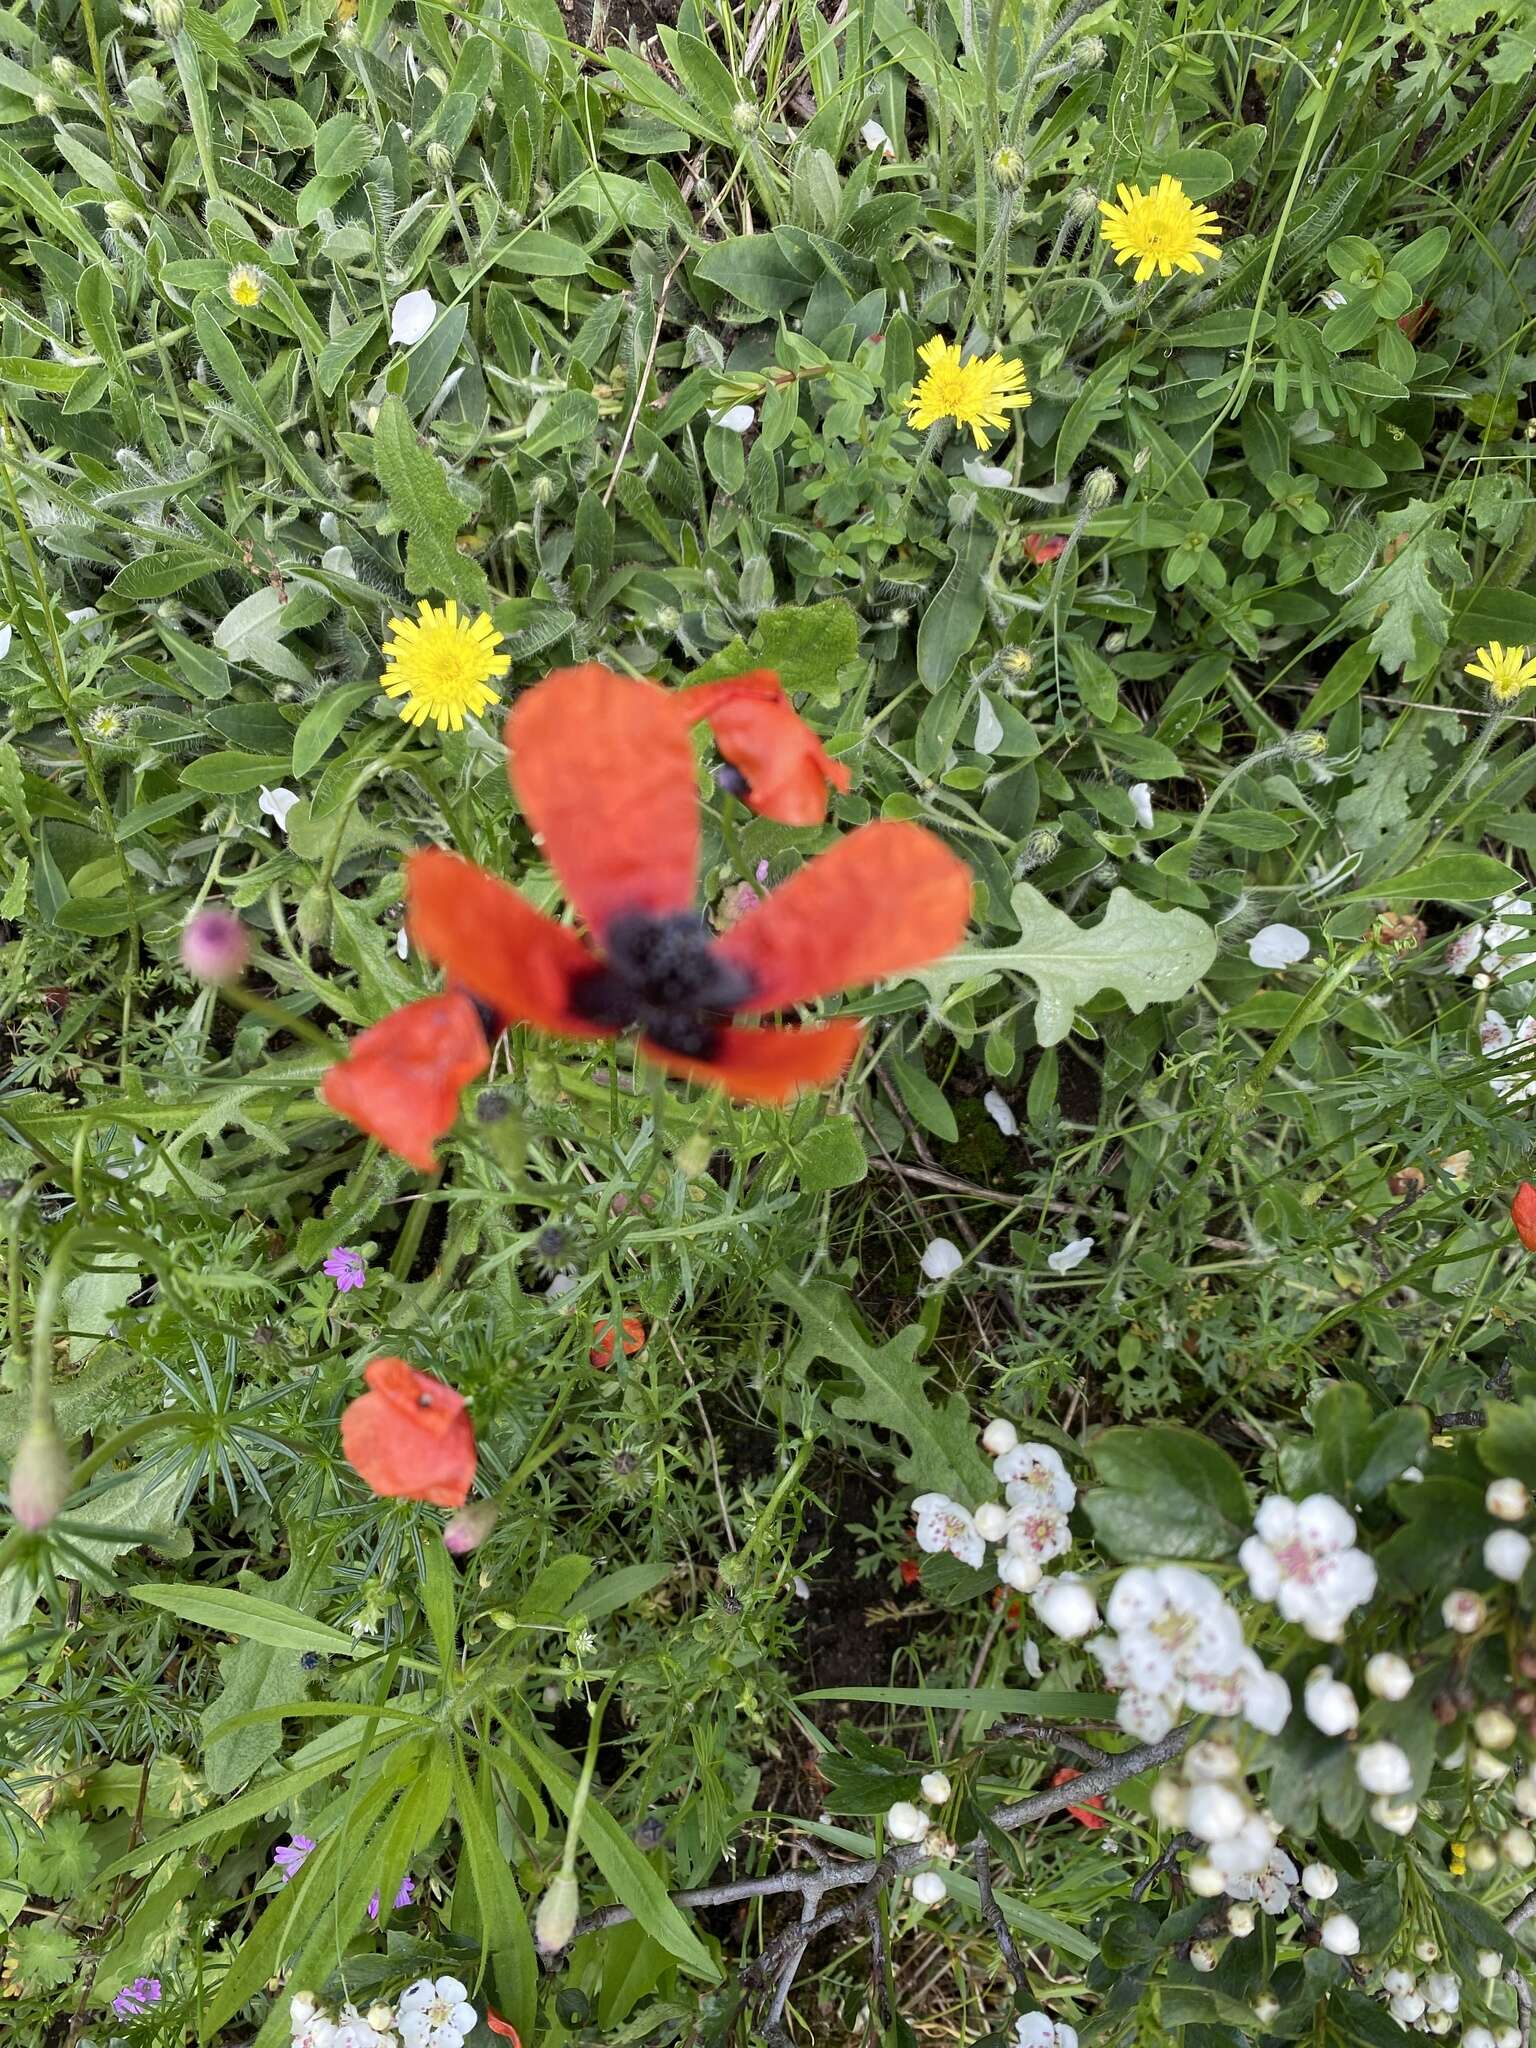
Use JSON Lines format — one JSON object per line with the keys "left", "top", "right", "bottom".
{"left": 1083, "top": 1423, "right": 1253, "bottom": 1563}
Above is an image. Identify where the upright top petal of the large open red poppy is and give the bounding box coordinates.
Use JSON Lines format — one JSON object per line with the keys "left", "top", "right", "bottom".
{"left": 506, "top": 662, "right": 698, "bottom": 938}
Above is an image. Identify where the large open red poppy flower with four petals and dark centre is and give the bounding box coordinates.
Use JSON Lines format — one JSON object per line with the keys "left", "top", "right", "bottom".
{"left": 397, "top": 664, "right": 971, "bottom": 1102}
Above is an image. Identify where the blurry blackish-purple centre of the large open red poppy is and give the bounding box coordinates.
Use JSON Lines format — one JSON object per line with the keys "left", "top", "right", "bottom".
{"left": 571, "top": 911, "right": 752, "bottom": 1059}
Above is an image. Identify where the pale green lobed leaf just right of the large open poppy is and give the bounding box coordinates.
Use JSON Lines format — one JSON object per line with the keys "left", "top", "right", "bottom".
{"left": 913, "top": 883, "right": 1217, "bottom": 1044}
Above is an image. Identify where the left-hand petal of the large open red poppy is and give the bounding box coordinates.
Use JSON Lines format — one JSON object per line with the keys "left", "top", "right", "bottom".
{"left": 406, "top": 848, "right": 604, "bottom": 1038}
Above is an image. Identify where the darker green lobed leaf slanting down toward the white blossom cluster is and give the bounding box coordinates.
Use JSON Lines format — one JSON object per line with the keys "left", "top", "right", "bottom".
{"left": 768, "top": 1272, "right": 997, "bottom": 1507}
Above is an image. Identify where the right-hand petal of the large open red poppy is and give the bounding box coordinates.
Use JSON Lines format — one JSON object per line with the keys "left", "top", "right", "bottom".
{"left": 715, "top": 821, "right": 971, "bottom": 1012}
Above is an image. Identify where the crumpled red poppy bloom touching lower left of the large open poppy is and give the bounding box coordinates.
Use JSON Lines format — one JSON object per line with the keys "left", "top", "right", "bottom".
{"left": 319, "top": 993, "right": 492, "bottom": 1174}
